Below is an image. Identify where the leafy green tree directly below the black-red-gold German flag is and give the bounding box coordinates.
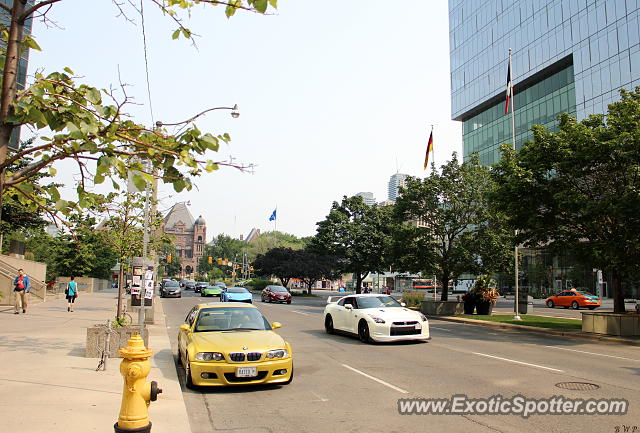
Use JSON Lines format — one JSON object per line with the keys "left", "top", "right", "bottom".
{"left": 392, "top": 153, "right": 512, "bottom": 301}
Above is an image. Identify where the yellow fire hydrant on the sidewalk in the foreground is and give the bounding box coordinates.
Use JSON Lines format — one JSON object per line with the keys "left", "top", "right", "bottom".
{"left": 113, "top": 334, "right": 162, "bottom": 433}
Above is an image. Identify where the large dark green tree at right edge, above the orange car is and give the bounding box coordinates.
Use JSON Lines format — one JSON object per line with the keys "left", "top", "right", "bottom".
{"left": 494, "top": 87, "right": 640, "bottom": 312}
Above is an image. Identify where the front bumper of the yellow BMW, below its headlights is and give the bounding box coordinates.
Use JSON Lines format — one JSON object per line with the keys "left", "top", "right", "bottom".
{"left": 190, "top": 357, "right": 293, "bottom": 386}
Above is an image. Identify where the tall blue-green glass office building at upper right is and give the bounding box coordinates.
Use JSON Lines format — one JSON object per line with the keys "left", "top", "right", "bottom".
{"left": 449, "top": 0, "right": 640, "bottom": 164}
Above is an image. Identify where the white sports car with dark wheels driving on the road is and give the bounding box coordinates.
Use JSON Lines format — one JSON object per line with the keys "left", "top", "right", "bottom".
{"left": 324, "top": 295, "right": 431, "bottom": 343}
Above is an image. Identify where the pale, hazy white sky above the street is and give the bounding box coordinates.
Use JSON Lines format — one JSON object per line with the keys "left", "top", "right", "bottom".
{"left": 28, "top": 0, "right": 462, "bottom": 239}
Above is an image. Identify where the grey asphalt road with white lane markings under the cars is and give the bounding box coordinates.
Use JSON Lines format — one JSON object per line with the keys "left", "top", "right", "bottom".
{"left": 162, "top": 292, "right": 640, "bottom": 433}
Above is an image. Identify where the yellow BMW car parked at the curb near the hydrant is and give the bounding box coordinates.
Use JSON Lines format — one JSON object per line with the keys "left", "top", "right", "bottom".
{"left": 178, "top": 302, "right": 293, "bottom": 387}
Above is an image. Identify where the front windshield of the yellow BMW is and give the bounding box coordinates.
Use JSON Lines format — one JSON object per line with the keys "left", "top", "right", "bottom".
{"left": 194, "top": 307, "right": 271, "bottom": 332}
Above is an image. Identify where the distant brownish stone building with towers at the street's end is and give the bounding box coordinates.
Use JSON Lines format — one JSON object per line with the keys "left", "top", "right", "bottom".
{"left": 162, "top": 202, "right": 207, "bottom": 277}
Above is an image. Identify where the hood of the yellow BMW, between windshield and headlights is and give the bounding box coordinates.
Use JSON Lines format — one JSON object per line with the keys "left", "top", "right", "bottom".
{"left": 191, "top": 331, "right": 285, "bottom": 353}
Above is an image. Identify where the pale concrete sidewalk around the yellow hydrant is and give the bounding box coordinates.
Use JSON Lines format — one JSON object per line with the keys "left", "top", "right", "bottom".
{"left": 0, "top": 291, "right": 191, "bottom": 433}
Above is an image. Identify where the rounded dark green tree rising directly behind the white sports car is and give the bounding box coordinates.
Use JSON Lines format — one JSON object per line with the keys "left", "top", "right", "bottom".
{"left": 311, "top": 196, "right": 391, "bottom": 293}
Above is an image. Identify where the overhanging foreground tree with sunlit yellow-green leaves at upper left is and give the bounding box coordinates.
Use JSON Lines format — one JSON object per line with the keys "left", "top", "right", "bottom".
{"left": 0, "top": 0, "right": 276, "bottom": 230}
